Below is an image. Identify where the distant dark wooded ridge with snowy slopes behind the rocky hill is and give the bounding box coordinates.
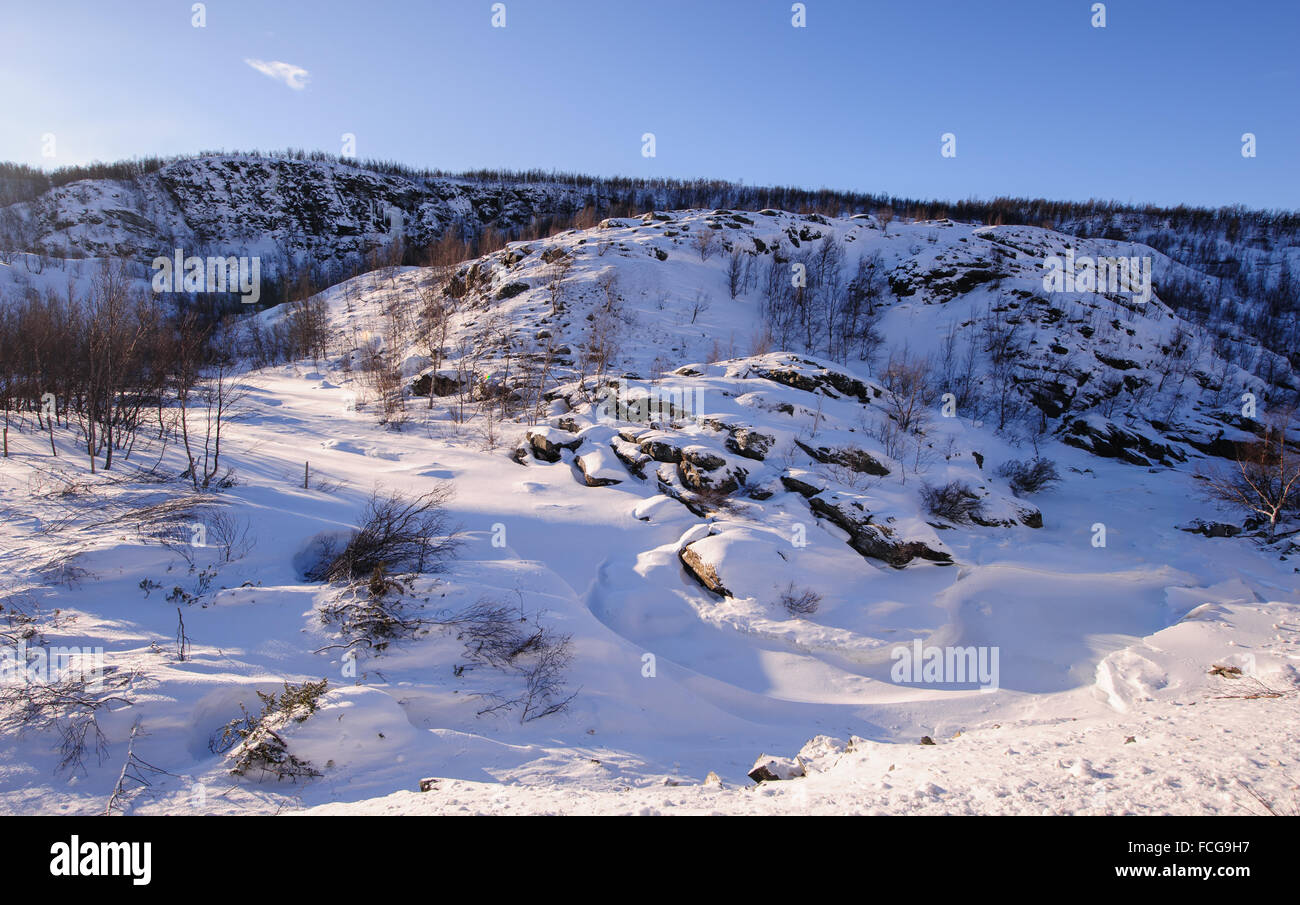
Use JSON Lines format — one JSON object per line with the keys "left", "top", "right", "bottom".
{"left": 0, "top": 152, "right": 1300, "bottom": 367}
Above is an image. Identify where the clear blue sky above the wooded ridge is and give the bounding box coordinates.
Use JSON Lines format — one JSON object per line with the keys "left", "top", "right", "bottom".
{"left": 0, "top": 0, "right": 1300, "bottom": 208}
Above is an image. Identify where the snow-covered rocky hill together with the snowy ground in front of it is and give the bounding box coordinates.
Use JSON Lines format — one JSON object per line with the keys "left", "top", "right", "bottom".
{"left": 0, "top": 187, "right": 1300, "bottom": 813}
